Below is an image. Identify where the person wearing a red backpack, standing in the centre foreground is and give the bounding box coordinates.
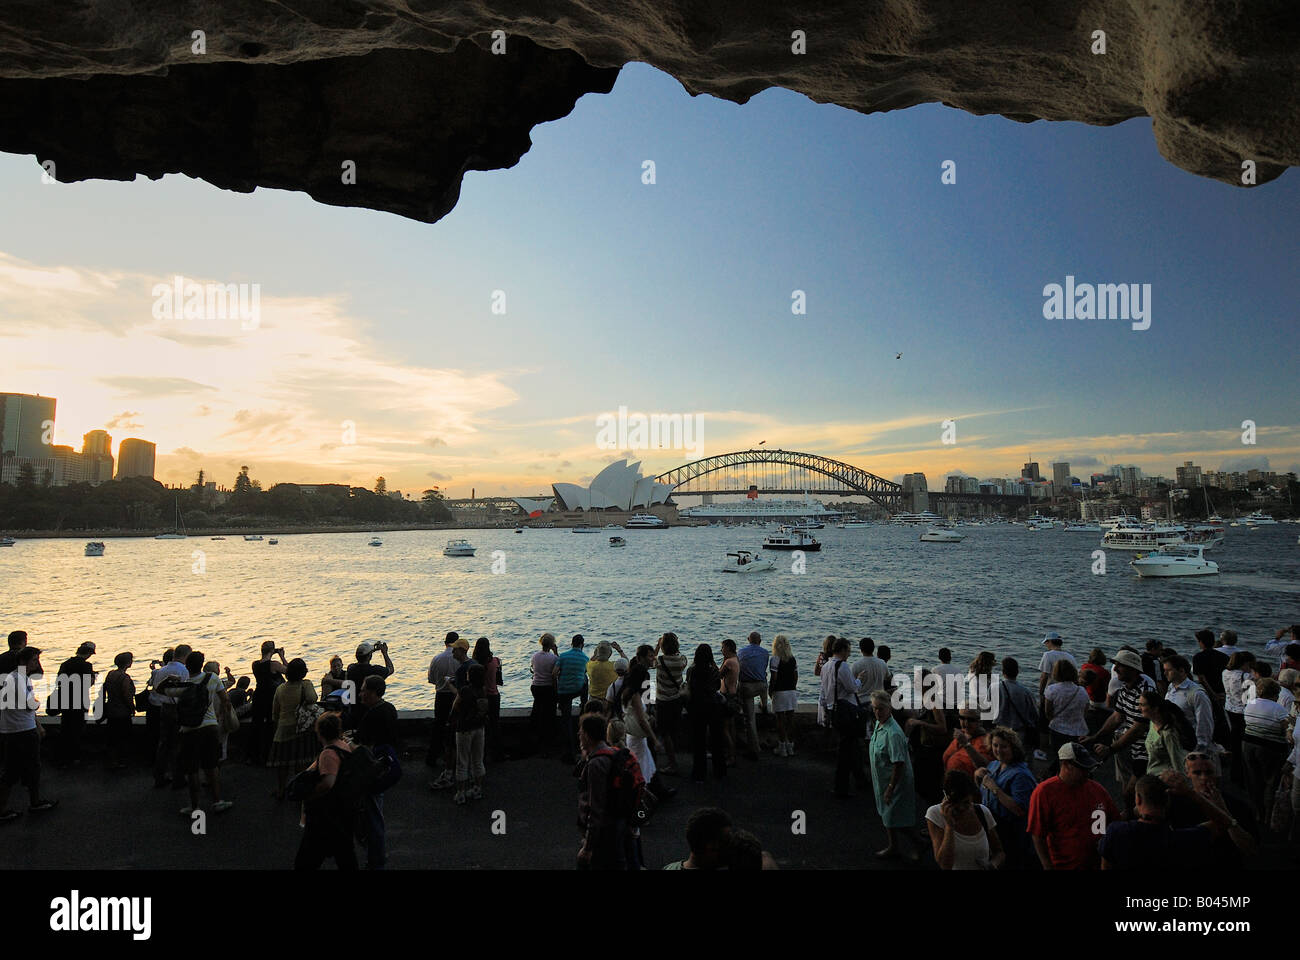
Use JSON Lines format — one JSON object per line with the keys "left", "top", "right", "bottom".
{"left": 577, "top": 714, "right": 645, "bottom": 870}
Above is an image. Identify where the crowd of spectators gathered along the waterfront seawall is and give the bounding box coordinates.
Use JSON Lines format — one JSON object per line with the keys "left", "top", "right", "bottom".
{"left": 0, "top": 627, "right": 1300, "bottom": 869}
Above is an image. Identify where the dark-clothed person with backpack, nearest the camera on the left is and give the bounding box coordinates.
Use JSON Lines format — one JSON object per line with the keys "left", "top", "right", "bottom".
{"left": 294, "top": 713, "right": 358, "bottom": 870}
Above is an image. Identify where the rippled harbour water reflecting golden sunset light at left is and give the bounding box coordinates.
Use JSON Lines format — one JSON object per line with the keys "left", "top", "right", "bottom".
{"left": 0, "top": 524, "right": 1300, "bottom": 709}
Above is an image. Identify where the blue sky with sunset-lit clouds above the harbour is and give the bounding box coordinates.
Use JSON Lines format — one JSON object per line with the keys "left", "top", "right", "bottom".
{"left": 0, "top": 64, "right": 1300, "bottom": 497}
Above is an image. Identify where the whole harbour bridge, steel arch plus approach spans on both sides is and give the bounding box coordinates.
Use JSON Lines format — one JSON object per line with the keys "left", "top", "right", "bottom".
{"left": 449, "top": 446, "right": 1028, "bottom": 513}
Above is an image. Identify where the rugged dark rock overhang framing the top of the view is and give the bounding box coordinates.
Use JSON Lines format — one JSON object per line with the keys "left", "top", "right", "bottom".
{"left": 0, "top": 0, "right": 1300, "bottom": 222}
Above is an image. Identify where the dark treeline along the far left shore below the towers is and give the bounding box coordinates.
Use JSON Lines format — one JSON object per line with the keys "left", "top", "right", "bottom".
{"left": 0, "top": 467, "right": 451, "bottom": 531}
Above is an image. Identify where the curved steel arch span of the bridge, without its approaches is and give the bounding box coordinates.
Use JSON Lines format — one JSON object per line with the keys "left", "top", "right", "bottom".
{"left": 655, "top": 447, "right": 904, "bottom": 511}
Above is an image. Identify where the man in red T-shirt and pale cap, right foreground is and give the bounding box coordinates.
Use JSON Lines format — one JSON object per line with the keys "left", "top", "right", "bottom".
{"left": 1027, "top": 743, "right": 1119, "bottom": 870}
